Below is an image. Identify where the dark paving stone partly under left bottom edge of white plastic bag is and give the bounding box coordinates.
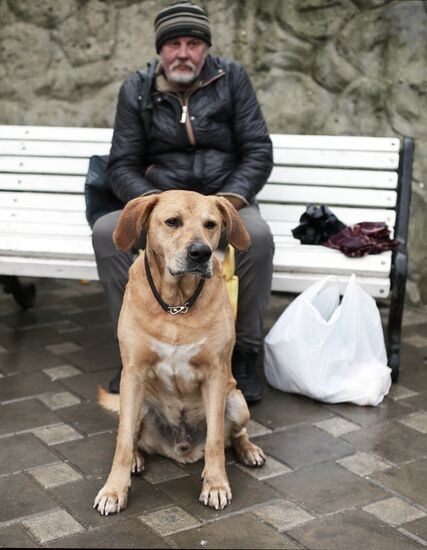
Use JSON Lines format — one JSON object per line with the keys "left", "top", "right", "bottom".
{"left": 250, "top": 387, "right": 332, "bottom": 429}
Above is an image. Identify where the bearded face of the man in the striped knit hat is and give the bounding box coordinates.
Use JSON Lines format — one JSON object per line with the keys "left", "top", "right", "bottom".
{"left": 160, "top": 36, "right": 209, "bottom": 84}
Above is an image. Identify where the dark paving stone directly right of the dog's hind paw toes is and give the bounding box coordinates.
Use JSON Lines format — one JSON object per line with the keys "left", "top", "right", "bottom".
{"left": 257, "top": 426, "right": 354, "bottom": 469}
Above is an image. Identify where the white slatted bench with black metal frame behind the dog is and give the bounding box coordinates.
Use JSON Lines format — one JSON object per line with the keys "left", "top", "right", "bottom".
{"left": 0, "top": 126, "right": 413, "bottom": 379}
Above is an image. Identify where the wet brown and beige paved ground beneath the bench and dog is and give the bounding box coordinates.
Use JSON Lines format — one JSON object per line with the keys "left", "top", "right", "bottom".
{"left": 0, "top": 280, "right": 427, "bottom": 550}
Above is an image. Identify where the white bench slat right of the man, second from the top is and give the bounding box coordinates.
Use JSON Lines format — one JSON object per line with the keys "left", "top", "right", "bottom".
{"left": 273, "top": 148, "right": 399, "bottom": 170}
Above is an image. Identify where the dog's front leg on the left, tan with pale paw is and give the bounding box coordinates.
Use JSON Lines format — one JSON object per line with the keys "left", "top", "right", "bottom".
{"left": 94, "top": 367, "right": 144, "bottom": 516}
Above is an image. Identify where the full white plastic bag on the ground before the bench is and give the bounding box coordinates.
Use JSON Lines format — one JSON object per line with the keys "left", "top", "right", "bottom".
{"left": 264, "top": 275, "right": 391, "bottom": 405}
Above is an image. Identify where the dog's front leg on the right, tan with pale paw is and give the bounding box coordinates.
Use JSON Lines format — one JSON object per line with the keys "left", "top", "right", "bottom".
{"left": 199, "top": 369, "right": 231, "bottom": 510}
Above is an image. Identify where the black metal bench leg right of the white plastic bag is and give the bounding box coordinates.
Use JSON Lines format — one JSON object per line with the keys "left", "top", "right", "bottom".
{"left": 387, "top": 250, "right": 408, "bottom": 382}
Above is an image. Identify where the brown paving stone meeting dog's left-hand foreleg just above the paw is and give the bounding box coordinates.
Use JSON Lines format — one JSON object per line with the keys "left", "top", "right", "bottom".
{"left": 55, "top": 433, "right": 116, "bottom": 479}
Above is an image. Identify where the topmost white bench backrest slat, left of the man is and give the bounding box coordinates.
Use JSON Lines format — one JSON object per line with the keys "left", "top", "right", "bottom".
{"left": 0, "top": 125, "right": 113, "bottom": 143}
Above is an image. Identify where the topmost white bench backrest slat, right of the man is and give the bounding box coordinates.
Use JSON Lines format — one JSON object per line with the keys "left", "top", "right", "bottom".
{"left": 270, "top": 134, "right": 400, "bottom": 153}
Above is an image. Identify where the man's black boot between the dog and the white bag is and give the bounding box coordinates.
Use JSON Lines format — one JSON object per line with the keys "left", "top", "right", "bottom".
{"left": 231, "top": 348, "right": 262, "bottom": 403}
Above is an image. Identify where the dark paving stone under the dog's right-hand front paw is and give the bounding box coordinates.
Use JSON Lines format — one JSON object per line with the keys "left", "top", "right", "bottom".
{"left": 161, "top": 465, "right": 282, "bottom": 520}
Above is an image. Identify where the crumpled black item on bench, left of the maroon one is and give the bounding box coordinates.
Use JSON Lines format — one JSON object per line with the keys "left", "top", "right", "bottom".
{"left": 292, "top": 204, "right": 347, "bottom": 244}
